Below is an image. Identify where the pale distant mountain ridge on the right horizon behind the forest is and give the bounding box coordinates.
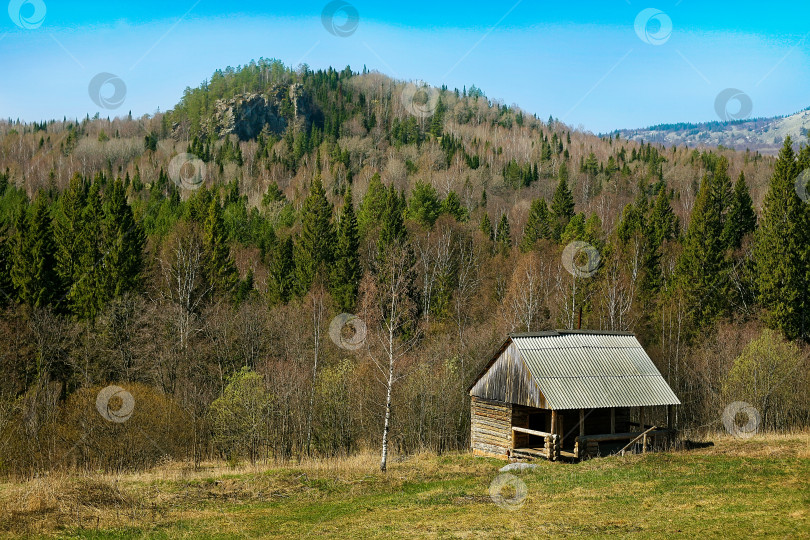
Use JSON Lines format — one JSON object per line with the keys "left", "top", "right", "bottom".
{"left": 613, "top": 107, "right": 810, "bottom": 155}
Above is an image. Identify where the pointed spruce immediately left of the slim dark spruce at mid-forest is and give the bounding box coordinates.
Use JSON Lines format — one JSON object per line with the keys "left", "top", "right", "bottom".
{"left": 295, "top": 175, "right": 335, "bottom": 296}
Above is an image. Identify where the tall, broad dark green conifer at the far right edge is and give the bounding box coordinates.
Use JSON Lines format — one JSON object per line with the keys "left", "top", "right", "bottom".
{"left": 754, "top": 137, "right": 808, "bottom": 339}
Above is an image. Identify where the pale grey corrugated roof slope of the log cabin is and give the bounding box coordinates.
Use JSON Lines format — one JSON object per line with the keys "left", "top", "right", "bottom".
{"left": 509, "top": 332, "right": 681, "bottom": 409}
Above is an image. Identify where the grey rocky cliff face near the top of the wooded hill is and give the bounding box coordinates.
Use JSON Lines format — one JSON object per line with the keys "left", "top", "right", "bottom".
{"left": 204, "top": 84, "right": 313, "bottom": 141}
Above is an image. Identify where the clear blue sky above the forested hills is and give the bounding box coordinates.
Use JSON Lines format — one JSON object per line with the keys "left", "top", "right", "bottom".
{"left": 0, "top": 0, "right": 810, "bottom": 132}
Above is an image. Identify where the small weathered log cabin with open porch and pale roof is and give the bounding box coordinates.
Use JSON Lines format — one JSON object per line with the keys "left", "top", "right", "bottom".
{"left": 469, "top": 330, "right": 681, "bottom": 460}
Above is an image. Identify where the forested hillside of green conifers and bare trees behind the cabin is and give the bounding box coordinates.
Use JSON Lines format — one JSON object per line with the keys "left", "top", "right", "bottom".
{"left": 0, "top": 60, "right": 810, "bottom": 473}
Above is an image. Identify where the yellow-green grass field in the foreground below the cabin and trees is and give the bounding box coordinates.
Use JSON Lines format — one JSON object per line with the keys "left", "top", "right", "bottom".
{"left": 0, "top": 433, "right": 810, "bottom": 539}
